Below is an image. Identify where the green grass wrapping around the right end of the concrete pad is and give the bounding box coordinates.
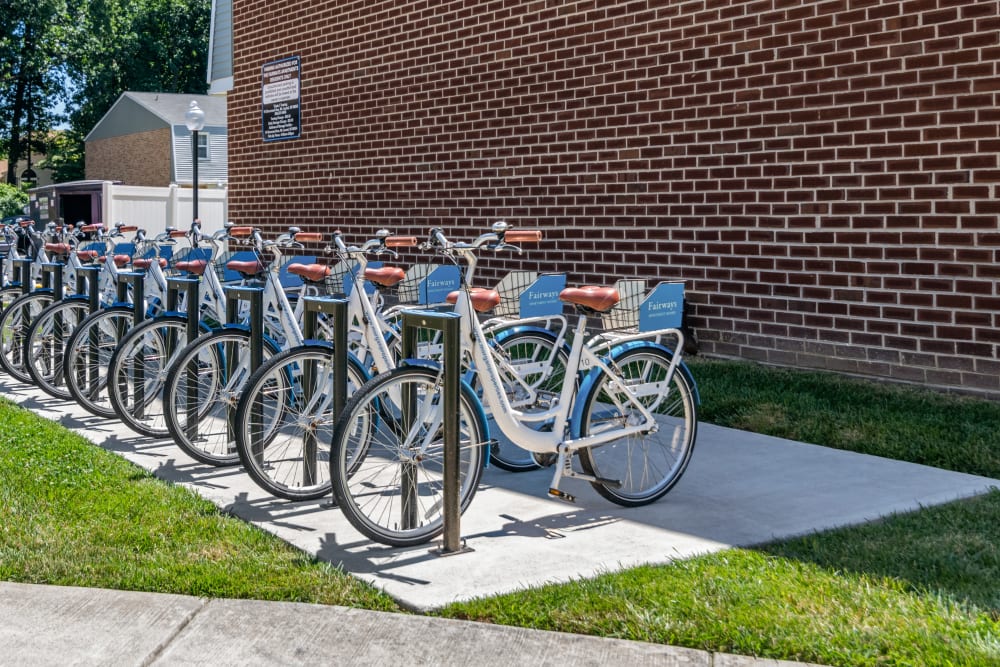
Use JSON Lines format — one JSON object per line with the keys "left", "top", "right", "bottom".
{"left": 441, "top": 359, "right": 1000, "bottom": 666}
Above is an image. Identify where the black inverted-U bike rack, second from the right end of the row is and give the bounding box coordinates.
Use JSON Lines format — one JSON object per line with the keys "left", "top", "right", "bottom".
{"left": 298, "top": 296, "right": 347, "bottom": 485}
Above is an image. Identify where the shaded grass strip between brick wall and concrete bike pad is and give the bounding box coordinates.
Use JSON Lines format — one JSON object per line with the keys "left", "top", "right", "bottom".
{"left": 690, "top": 359, "right": 1000, "bottom": 478}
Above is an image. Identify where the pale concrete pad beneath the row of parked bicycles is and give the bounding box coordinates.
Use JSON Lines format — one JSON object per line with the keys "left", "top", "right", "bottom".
{"left": 0, "top": 381, "right": 1000, "bottom": 609}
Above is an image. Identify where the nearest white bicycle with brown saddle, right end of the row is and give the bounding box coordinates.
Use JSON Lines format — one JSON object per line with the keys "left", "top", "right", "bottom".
{"left": 330, "top": 223, "right": 697, "bottom": 546}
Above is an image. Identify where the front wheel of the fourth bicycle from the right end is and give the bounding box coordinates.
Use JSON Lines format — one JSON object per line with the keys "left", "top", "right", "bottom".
{"left": 107, "top": 315, "right": 193, "bottom": 438}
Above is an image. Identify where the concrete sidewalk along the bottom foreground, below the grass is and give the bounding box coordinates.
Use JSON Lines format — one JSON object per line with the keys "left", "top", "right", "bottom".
{"left": 0, "top": 582, "right": 820, "bottom": 667}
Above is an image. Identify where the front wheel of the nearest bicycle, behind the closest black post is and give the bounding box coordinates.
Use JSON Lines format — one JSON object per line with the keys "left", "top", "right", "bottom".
{"left": 330, "top": 366, "right": 488, "bottom": 547}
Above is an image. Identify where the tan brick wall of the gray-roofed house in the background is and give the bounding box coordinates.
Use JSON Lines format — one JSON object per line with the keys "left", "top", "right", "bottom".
{"left": 86, "top": 128, "right": 171, "bottom": 187}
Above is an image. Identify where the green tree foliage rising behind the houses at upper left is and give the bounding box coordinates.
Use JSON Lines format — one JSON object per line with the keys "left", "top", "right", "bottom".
{"left": 0, "top": 0, "right": 211, "bottom": 182}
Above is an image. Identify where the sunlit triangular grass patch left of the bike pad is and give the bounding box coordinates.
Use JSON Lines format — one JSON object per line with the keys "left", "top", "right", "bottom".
{"left": 0, "top": 401, "right": 398, "bottom": 610}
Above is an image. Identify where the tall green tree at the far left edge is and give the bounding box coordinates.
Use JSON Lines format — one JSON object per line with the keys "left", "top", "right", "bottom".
{"left": 0, "top": 0, "right": 66, "bottom": 185}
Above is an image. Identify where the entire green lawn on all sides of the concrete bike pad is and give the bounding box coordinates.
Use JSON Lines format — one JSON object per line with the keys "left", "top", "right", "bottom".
{"left": 0, "top": 360, "right": 1000, "bottom": 666}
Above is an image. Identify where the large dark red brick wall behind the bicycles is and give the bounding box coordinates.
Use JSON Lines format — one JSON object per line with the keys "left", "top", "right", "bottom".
{"left": 229, "top": 0, "right": 1000, "bottom": 393}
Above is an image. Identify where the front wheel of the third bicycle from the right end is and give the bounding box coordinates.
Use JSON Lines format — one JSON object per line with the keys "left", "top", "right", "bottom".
{"left": 163, "top": 327, "right": 278, "bottom": 466}
